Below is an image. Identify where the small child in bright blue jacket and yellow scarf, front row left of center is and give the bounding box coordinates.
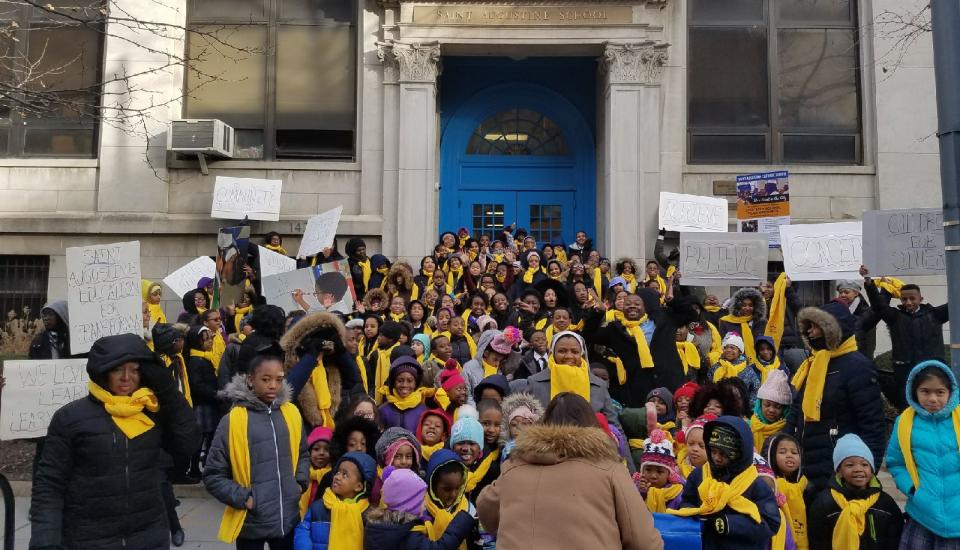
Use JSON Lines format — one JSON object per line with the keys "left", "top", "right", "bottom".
{"left": 293, "top": 451, "right": 377, "bottom": 550}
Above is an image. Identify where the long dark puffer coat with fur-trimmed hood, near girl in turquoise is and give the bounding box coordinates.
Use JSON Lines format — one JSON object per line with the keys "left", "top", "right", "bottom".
{"left": 784, "top": 302, "right": 886, "bottom": 490}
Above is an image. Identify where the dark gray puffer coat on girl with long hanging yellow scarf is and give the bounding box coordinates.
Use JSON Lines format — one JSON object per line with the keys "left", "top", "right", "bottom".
{"left": 203, "top": 375, "right": 310, "bottom": 539}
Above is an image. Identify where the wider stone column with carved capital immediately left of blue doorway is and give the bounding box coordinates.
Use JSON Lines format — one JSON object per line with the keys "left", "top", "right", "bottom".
{"left": 385, "top": 42, "right": 440, "bottom": 261}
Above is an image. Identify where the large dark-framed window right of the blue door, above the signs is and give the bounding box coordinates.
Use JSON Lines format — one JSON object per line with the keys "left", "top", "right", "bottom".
{"left": 687, "top": 0, "right": 862, "bottom": 164}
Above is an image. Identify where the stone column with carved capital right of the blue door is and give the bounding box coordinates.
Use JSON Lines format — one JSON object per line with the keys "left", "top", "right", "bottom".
{"left": 597, "top": 41, "right": 668, "bottom": 261}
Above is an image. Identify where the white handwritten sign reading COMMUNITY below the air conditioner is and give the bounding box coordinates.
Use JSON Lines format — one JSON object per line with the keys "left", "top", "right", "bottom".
{"left": 210, "top": 176, "right": 283, "bottom": 222}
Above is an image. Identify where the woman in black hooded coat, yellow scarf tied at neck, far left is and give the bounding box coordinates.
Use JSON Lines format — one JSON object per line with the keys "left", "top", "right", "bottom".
{"left": 30, "top": 334, "right": 200, "bottom": 550}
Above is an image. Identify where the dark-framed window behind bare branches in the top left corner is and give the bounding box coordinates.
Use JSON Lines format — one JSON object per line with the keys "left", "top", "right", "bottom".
{"left": 0, "top": 0, "right": 107, "bottom": 158}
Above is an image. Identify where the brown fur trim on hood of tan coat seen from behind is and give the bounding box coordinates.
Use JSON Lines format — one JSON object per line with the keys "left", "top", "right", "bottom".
{"left": 510, "top": 425, "right": 620, "bottom": 465}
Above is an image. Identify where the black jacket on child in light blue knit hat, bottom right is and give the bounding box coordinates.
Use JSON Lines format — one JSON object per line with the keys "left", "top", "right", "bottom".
{"left": 807, "top": 476, "right": 903, "bottom": 550}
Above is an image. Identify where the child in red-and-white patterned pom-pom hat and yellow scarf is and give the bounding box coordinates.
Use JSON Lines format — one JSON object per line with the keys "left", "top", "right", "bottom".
{"left": 633, "top": 429, "right": 683, "bottom": 514}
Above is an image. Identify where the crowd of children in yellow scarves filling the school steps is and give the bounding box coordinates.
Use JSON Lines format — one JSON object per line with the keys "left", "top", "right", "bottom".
{"left": 26, "top": 225, "right": 960, "bottom": 550}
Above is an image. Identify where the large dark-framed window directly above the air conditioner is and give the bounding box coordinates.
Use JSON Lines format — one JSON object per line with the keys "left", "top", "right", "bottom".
{"left": 184, "top": 0, "right": 358, "bottom": 160}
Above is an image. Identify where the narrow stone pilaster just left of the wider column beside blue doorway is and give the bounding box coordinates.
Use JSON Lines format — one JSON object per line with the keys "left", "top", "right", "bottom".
{"left": 377, "top": 42, "right": 400, "bottom": 258}
